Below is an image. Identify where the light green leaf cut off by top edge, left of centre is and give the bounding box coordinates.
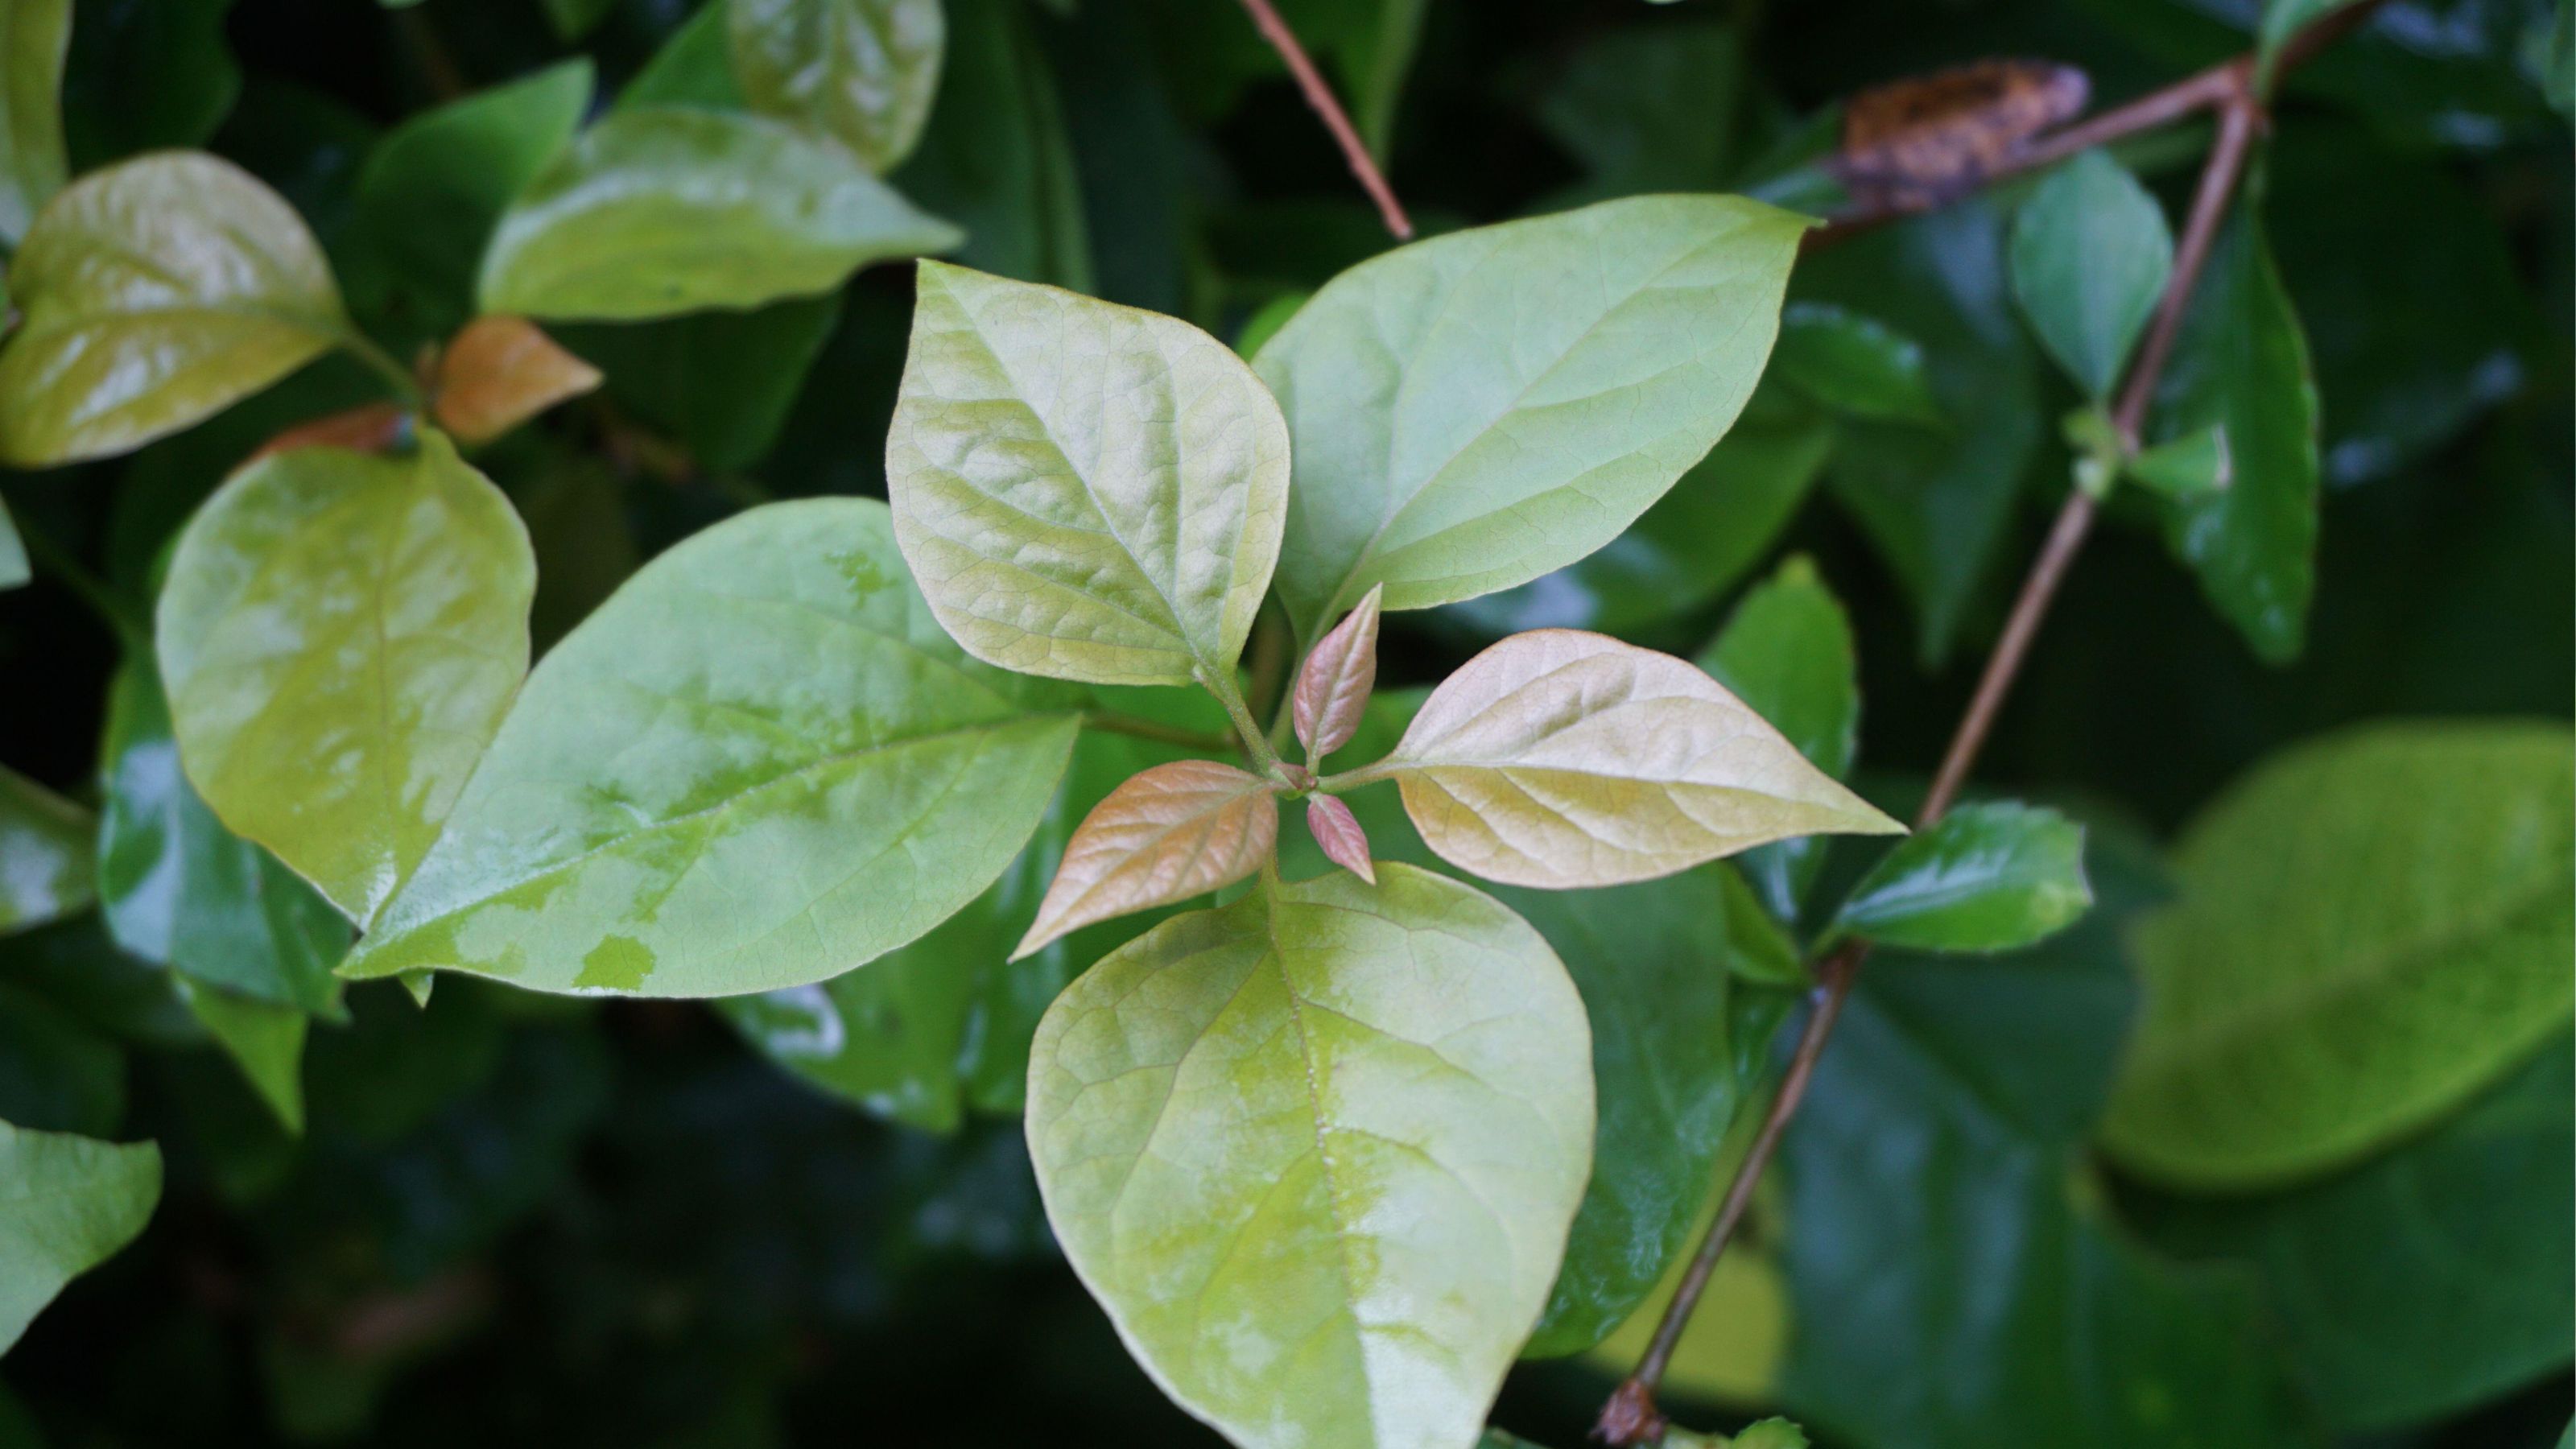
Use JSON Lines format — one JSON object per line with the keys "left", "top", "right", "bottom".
{"left": 719, "top": 0, "right": 948, "bottom": 173}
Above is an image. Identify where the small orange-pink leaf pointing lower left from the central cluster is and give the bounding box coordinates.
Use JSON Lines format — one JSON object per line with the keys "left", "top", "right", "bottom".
{"left": 1009, "top": 761, "right": 1280, "bottom": 962}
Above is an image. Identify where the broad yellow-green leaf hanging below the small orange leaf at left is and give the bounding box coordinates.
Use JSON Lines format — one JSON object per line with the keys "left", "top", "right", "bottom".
{"left": 155, "top": 428, "right": 536, "bottom": 926}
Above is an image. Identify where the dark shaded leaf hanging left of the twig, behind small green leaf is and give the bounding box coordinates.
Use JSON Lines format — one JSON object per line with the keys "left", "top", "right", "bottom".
{"left": 1798, "top": 199, "right": 2043, "bottom": 663}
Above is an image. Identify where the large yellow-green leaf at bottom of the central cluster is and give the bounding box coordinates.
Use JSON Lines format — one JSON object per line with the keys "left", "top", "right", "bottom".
{"left": 1028, "top": 864, "right": 1592, "bottom": 1449}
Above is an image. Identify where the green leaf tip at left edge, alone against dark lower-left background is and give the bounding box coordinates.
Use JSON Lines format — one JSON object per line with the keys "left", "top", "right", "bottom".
{"left": 0, "top": 1121, "right": 159, "bottom": 1353}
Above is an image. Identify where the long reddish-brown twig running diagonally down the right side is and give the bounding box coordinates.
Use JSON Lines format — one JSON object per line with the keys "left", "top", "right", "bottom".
{"left": 1592, "top": 14, "right": 2339, "bottom": 1444}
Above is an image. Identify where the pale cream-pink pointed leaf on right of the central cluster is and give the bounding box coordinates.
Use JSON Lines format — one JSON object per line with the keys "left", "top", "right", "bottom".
{"left": 1352, "top": 629, "right": 1904, "bottom": 890}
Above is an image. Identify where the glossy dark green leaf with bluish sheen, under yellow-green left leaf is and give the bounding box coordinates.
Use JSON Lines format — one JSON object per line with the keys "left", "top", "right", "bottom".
{"left": 98, "top": 660, "right": 348, "bottom": 1011}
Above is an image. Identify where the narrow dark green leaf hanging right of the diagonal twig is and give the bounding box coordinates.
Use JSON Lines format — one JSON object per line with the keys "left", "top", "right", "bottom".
{"left": 2153, "top": 208, "right": 2318, "bottom": 663}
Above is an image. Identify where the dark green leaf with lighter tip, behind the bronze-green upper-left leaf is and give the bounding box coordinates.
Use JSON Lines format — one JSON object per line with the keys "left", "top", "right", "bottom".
{"left": 337, "top": 60, "right": 592, "bottom": 343}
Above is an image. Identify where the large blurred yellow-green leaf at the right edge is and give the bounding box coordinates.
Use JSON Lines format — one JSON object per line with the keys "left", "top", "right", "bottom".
{"left": 2102, "top": 722, "right": 2576, "bottom": 1189}
